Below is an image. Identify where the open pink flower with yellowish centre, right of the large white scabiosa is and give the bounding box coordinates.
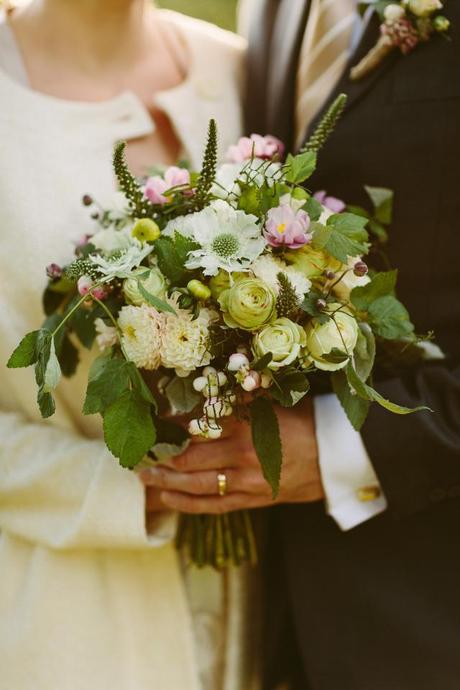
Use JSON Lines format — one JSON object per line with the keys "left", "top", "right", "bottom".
{"left": 264, "top": 204, "right": 311, "bottom": 249}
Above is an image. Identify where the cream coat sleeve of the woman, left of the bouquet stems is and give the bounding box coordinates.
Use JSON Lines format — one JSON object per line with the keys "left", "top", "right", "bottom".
{"left": 0, "top": 412, "right": 174, "bottom": 549}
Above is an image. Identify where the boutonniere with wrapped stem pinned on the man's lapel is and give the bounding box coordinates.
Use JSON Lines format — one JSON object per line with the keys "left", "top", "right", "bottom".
{"left": 350, "top": 0, "right": 450, "bottom": 81}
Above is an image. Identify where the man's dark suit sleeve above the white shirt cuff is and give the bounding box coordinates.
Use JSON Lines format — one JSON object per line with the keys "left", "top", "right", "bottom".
{"left": 362, "top": 363, "right": 460, "bottom": 517}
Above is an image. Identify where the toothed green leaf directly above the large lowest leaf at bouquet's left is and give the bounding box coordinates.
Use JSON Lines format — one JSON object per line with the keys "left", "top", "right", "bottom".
{"left": 83, "top": 354, "right": 134, "bottom": 415}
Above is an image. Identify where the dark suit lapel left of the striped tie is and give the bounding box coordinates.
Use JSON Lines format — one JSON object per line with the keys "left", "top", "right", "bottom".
{"left": 265, "top": 0, "right": 310, "bottom": 148}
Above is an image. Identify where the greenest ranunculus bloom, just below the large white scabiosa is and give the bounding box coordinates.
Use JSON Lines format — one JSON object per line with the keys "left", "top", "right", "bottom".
{"left": 219, "top": 278, "right": 276, "bottom": 331}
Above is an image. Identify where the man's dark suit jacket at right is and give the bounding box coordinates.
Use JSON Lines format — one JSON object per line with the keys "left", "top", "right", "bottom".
{"left": 247, "top": 0, "right": 460, "bottom": 690}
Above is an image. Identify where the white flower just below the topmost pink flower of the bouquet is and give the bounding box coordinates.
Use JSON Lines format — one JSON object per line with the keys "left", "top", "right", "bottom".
{"left": 211, "top": 158, "right": 282, "bottom": 201}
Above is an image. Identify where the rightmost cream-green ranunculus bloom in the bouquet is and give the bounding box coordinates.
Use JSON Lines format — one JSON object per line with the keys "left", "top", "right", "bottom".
{"left": 304, "top": 303, "right": 358, "bottom": 371}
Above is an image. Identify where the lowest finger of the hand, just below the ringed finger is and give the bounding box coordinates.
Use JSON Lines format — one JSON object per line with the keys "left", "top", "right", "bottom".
{"left": 160, "top": 491, "right": 266, "bottom": 515}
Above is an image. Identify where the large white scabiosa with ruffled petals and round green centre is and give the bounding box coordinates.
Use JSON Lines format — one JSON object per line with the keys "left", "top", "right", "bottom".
{"left": 163, "top": 201, "right": 265, "bottom": 276}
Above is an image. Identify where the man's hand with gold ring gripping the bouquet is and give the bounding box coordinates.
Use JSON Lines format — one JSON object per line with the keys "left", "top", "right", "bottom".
{"left": 142, "top": 399, "right": 324, "bottom": 513}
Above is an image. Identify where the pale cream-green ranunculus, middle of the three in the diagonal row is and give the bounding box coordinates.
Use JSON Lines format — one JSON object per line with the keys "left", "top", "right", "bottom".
{"left": 252, "top": 317, "right": 307, "bottom": 371}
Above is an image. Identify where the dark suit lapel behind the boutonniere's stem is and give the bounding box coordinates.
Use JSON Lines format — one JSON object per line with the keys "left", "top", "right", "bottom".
{"left": 305, "top": 11, "right": 399, "bottom": 149}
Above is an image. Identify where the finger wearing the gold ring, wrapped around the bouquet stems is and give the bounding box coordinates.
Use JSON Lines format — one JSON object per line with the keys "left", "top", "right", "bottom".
{"left": 143, "top": 467, "right": 270, "bottom": 496}
